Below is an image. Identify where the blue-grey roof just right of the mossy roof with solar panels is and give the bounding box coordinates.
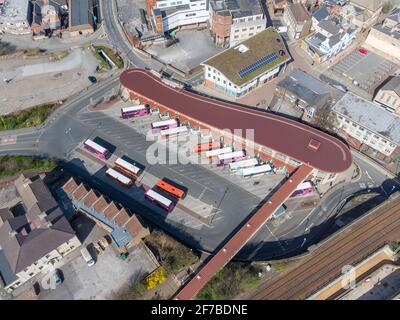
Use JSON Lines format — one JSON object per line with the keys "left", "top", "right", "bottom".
{"left": 278, "top": 69, "right": 329, "bottom": 105}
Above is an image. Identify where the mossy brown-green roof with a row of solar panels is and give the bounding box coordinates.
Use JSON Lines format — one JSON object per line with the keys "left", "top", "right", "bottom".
{"left": 202, "top": 27, "right": 291, "bottom": 86}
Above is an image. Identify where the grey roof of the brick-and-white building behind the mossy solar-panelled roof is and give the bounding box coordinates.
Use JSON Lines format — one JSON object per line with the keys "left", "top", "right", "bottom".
{"left": 210, "top": 0, "right": 264, "bottom": 19}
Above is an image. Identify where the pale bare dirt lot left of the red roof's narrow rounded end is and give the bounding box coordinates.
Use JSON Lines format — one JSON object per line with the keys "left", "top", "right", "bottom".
{"left": 0, "top": 49, "right": 97, "bottom": 114}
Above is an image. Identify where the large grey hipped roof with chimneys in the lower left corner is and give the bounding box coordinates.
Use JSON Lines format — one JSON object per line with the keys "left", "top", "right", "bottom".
{"left": 0, "top": 175, "right": 75, "bottom": 274}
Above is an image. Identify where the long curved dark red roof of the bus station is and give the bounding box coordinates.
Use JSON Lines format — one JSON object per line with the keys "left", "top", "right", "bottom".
{"left": 120, "top": 69, "right": 352, "bottom": 173}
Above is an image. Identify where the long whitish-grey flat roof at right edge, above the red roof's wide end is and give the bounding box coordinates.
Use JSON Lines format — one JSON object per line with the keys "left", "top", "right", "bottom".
{"left": 332, "top": 92, "right": 400, "bottom": 144}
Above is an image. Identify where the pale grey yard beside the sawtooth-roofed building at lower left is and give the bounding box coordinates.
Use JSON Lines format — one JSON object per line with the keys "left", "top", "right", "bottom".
{"left": 39, "top": 217, "right": 157, "bottom": 300}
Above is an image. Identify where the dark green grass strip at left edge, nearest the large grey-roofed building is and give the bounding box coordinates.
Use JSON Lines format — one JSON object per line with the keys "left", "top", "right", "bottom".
{"left": 0, "top": 156, "right": 57, "bottom": 177}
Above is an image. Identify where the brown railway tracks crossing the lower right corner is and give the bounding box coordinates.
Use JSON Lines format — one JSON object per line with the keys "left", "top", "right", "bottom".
{"left": 250, "top": 197, "right": 400, "bottom": 300}
